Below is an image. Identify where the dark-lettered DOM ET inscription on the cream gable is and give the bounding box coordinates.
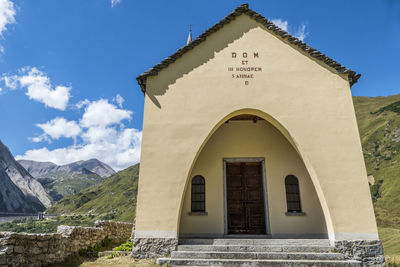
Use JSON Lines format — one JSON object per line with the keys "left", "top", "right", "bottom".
{"left": 228, "top": 51, "right": 262, "bottom": 85}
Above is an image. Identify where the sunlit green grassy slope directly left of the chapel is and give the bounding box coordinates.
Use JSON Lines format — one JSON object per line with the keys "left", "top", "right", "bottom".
{"left": 47, "top": 164, "right": 139, "bottom": 222}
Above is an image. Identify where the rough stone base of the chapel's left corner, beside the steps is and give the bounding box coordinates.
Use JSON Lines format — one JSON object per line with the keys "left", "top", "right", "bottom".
{"left": 132, "top": 238, "right": 178, "bottom": 259}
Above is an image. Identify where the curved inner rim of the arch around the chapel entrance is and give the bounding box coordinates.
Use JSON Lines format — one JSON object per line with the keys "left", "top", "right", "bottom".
{"left": 177, "top": 109, "right": 334, "bottom": 240}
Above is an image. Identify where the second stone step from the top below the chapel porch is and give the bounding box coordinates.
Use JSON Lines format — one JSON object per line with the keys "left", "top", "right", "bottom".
{"left": 177, "top": 245, "right": 332, "bottom": 252}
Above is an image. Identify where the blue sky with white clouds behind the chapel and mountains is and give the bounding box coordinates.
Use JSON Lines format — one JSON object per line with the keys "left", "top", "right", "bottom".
{"left": 0, "top": 0, "right": 400, "bottom": 169}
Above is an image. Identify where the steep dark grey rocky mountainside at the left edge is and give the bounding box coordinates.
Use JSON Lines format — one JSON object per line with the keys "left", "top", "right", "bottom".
{"left": 0, "top": 141, "right": 51, "bottom": 213}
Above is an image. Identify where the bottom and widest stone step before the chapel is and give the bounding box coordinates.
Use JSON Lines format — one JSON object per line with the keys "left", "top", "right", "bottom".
{"left": 157, "top": 258, "right": 361, "bottom": 267}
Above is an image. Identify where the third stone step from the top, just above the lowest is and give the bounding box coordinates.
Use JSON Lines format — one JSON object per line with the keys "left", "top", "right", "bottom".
{"left": 171, "top": 251, "right": 344, "bottom": 260}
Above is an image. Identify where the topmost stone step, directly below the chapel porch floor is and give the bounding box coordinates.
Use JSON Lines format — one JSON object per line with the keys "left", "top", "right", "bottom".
{"left": 179, "top": 238, "right": 330, "bottom": 246}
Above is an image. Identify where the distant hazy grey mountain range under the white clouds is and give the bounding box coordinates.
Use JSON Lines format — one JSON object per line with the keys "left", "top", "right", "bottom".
{"left": 18, "top": 159, "right": 115, "bottom": 201}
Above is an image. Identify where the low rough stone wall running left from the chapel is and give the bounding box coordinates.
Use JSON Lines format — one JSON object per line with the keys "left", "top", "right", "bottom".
{"left": 0, "top": 221, "right": 133, "bottom": 267}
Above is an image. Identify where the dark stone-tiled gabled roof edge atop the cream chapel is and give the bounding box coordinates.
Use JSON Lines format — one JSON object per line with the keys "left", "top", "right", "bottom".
{"left": 136, "top": 4, "right": 361, "bottom": 93}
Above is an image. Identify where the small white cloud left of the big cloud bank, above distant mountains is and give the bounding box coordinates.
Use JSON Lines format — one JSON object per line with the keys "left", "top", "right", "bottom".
{"left": 35, "top": 117, "right": 82, "bottom": 140}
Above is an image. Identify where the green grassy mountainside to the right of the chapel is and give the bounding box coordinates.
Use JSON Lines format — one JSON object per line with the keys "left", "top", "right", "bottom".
{"left": 354, "top": 95, "right": 400, "bottom": 229}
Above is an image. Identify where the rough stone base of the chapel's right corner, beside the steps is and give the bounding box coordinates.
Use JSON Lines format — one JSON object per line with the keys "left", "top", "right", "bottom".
{"left": 335, "top": 240, "right": 386, "bottom": 267}
